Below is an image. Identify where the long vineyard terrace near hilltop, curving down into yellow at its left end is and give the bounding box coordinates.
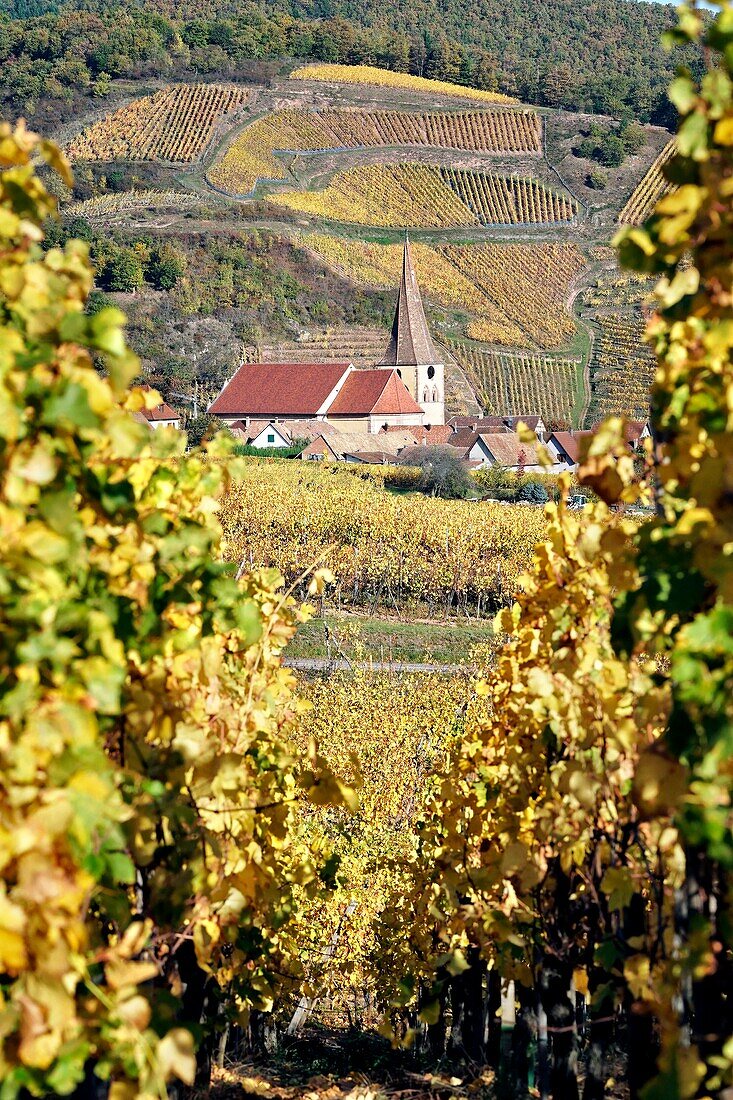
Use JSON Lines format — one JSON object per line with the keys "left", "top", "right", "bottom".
{"left": 209, "top": 110, "right": 541, "bottom": 195}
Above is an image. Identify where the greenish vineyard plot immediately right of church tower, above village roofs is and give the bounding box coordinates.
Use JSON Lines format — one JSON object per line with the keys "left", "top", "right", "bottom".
{"left": 450, "top": 341, "right": 582, "bottom": 424}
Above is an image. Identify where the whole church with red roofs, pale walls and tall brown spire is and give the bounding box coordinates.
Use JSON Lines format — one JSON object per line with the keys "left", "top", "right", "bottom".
{"left": 209, "top": 234, "right": 446, "bottom": 435}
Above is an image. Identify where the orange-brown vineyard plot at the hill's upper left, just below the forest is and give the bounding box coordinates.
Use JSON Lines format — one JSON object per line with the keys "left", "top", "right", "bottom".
{"left": 67, "top": 84, "right": 249, "bottom": 164}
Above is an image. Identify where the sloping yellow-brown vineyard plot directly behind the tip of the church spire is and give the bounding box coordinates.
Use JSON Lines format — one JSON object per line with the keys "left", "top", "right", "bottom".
{"left": 297, "top": 233, "right": 586, "bottom": 349}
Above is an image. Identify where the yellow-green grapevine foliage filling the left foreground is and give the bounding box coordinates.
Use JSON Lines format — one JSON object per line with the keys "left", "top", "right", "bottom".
{"left": 0, "top": 116, "right": 341, "bottom": 1100}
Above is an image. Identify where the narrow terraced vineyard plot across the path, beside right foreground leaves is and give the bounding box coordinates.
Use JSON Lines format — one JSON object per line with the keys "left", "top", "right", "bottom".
{"left": 589, "top": 311, "right": 655, "bottom": 424}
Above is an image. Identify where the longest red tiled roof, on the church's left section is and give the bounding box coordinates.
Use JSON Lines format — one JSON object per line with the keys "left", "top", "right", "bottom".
{"left": 209, "top": 363, "right": 350, "bottom": 417}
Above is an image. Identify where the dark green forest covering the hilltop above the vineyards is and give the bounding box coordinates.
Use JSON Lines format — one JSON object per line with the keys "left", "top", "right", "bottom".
{"left": 0, "top": 0, "right": 700, "bottom": 124}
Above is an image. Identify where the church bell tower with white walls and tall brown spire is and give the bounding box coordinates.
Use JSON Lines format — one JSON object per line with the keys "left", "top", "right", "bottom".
{"left": 380, "top": 233, "right": 446, "bottom": 425}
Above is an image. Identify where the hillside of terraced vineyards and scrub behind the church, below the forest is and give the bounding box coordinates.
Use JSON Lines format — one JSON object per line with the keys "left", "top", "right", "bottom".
{"left": 35, "top": 65, "right": 669, "bottom": 426}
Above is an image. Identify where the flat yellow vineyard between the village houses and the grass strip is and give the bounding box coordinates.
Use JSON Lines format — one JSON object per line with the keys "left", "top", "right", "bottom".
{"left": 220, "top": 462, "right": 545, "bottom": 615}
